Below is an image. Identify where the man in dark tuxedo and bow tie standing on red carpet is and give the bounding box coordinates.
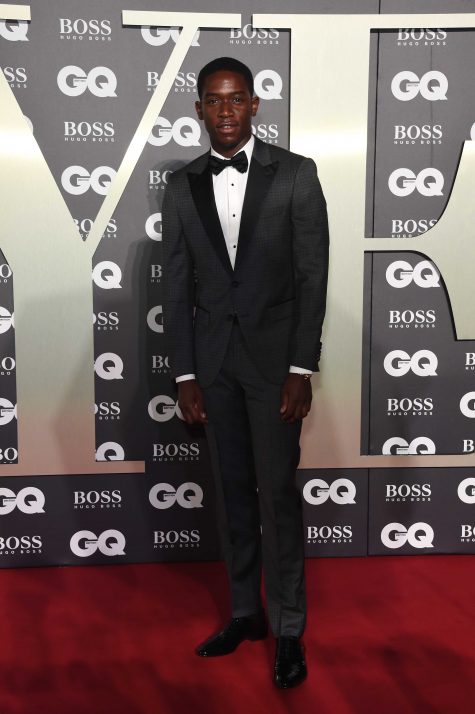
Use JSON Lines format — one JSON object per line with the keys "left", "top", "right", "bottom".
{"left": 163, "top": 57, "right": 328, "bottom": 687}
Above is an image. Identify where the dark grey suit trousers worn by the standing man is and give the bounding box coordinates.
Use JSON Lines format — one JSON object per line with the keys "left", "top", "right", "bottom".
{"left": 204, "top": 324, "right": 305, "bottom": 636}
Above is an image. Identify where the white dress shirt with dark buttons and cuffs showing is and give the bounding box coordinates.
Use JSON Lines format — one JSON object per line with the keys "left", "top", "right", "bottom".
{"left": 176, "top": 136, "right": 312, "bottom": 382}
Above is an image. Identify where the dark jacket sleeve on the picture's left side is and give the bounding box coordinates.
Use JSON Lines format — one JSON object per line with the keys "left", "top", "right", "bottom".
{"left": 162, "top": 181, "right": 196, "bottom": 378}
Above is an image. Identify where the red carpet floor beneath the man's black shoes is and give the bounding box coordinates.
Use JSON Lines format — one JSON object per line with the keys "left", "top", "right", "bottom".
{"left": 0, "top": 556, "right": 475, "bottom": 714}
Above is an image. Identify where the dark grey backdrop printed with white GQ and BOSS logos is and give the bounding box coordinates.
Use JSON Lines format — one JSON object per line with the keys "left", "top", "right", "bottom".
{"left": 0, "top": 0, "right": 475, "bottom": 567}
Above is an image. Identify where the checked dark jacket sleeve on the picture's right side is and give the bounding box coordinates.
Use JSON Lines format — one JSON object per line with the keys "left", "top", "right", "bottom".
{"left": 290, "top": 159, "right": 329, "bottom": 371}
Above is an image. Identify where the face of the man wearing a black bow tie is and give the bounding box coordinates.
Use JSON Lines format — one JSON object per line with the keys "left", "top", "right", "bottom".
{"left": 195, "top": 69, "right": 259, "bottom": 157}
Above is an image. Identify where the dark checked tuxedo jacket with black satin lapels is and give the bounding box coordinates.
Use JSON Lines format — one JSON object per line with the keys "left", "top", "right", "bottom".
{"left": 162, "top": 138, "right": 328, "bottom": 387}
